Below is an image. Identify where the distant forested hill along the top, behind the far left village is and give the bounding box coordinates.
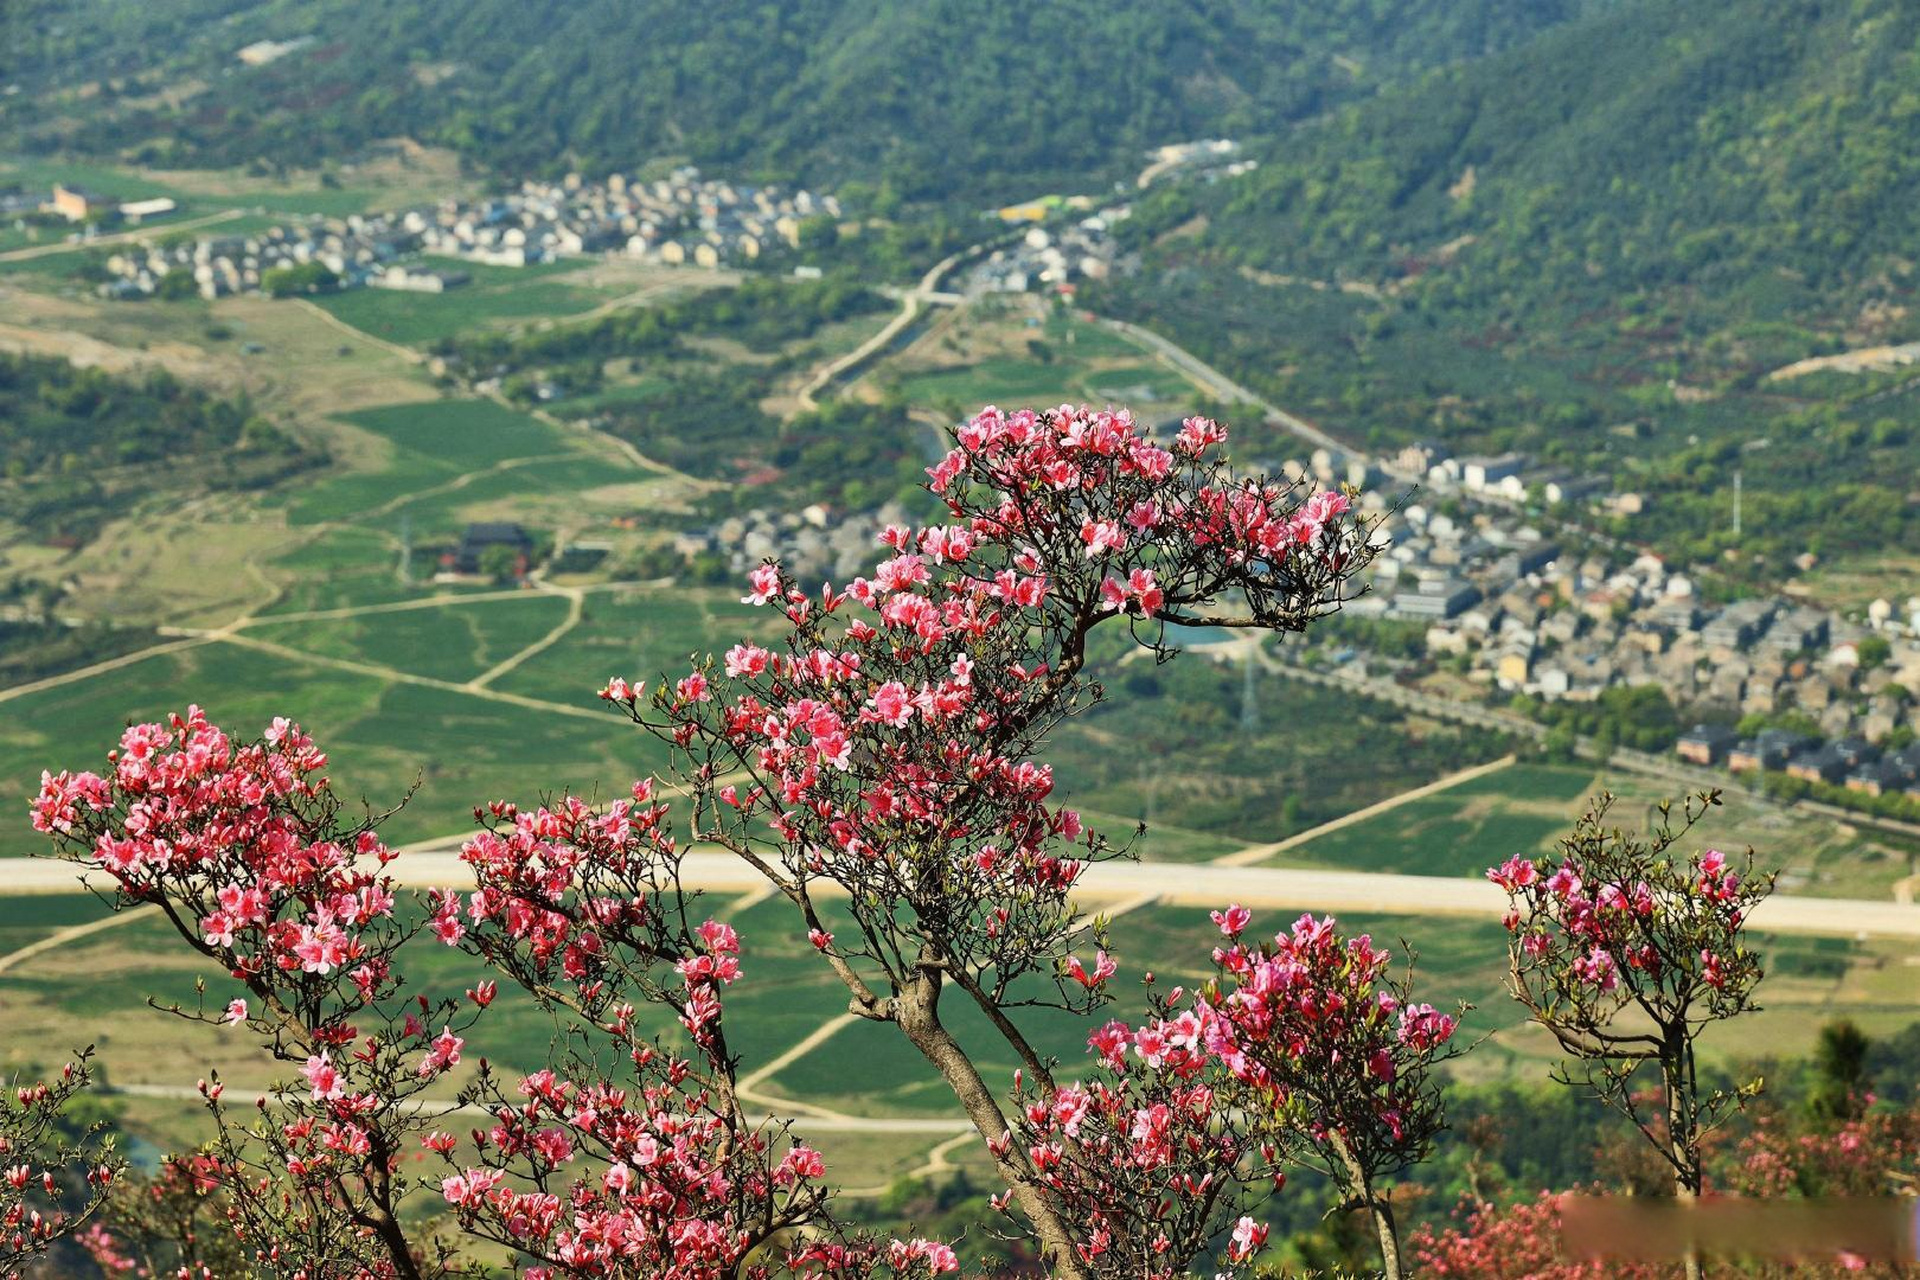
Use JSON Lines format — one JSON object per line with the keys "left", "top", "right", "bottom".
{"left": 15, "top": 0, "right": 1605, "bottom": 198}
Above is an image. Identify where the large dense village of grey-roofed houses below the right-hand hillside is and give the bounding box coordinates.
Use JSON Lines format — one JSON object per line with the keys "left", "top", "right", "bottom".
{"left": 1288, "top": 437, "right": 1920, "bottom": 743}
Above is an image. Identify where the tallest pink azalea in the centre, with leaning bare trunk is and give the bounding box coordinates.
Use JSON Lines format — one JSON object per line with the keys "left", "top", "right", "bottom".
{"left": 601, "top": 409, "right": 1371, "bottom": 1276}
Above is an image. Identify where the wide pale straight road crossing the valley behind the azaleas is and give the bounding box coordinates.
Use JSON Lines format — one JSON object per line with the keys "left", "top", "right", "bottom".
{"left": 0, "top": 846, "right": 1920, "bottom": 940}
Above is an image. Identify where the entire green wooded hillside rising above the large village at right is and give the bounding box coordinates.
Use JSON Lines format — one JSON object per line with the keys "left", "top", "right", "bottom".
{"left": 1092, "top": 0, "right": 1920, "bottom": 574}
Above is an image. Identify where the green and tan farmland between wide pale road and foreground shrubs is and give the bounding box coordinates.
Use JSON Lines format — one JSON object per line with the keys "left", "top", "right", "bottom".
{"left": 0, "top": 867, "right": 1920, "bottom": 1184}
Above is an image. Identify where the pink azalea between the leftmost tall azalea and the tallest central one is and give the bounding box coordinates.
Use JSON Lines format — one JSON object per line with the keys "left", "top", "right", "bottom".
{"left": 441, "top": 781, "right": 856, "bottom": 1280}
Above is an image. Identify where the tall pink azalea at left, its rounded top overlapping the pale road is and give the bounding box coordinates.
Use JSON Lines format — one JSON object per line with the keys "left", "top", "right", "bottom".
{"left": 33, "top": 706, "right": 486, "bottom": 1280}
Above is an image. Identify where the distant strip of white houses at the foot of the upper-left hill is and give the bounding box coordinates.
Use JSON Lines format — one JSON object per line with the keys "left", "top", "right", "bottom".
{"left": 86, "top": 169, "right": 841, "bottom": 297}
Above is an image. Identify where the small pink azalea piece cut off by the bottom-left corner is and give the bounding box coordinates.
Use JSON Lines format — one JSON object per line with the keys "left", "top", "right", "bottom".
{"left": 0, "top": 1050, "right": 125, "bottom": 1280}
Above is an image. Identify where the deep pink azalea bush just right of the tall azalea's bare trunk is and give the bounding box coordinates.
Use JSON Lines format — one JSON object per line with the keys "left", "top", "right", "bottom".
{"left": 1002, "top": 906, "right": 1457, "bottom": 1276}
